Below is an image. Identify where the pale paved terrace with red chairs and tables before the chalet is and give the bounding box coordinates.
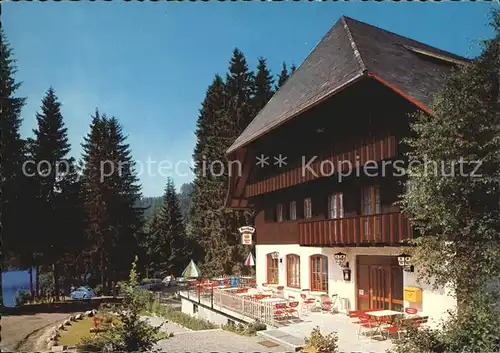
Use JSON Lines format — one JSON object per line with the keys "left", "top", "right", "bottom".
{"left": 180, "top": 280, "right": 426, "bottom": 352}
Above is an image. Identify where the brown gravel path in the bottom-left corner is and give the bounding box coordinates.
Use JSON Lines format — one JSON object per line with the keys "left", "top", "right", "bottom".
{"left": 0, "top": 313, "right": 71, "bottom": 352}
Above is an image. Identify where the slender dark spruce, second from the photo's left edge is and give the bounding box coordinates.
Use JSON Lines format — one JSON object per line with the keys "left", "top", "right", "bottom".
{"left": 31, "top": 87, "right": 78, "bottom": 295}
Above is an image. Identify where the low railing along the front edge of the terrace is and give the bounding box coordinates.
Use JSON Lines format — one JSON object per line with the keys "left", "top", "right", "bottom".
{"left": 180, "top": 285, "right": 277, "bottom": 326}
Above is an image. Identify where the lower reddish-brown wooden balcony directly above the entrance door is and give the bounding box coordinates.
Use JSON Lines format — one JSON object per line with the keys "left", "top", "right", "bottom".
{"left": 299, "top": 213, "right": 413, "bottom": 246}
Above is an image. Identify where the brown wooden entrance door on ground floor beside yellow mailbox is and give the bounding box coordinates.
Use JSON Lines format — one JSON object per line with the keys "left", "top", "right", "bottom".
{"left": 357, "top": 256, "right": 403, "bottom": 310}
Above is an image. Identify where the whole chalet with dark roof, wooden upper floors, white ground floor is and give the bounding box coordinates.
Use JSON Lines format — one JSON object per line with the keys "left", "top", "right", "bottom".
{"left": 226, "top": 17, "right": 468, "bottom": 322}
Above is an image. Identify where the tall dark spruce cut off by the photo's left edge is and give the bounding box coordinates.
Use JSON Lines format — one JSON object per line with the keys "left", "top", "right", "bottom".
{"left": 0, "top": 29, "right": 29, "bottom": 270}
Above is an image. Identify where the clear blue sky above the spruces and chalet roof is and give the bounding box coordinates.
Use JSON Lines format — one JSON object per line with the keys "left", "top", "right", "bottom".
{"left": 2, "top": 0, "right": 494, "bottom": 196}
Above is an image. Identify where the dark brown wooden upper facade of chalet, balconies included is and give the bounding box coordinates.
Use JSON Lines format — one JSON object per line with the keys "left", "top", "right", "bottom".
{"left": 230, "top": 82, "right": 414, "bottom": 246}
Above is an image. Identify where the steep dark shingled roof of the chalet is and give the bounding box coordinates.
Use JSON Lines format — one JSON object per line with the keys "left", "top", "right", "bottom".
{"left": 227, "top": 16, "right": 468, "bottom": 153}
